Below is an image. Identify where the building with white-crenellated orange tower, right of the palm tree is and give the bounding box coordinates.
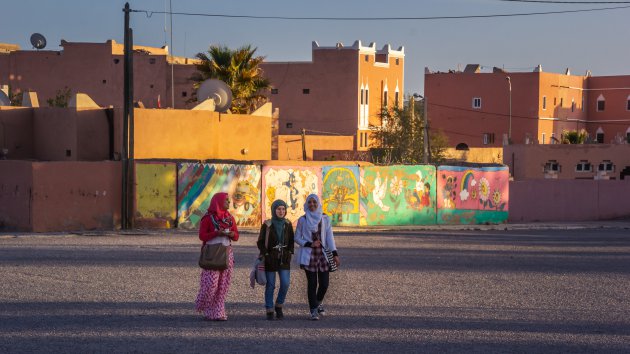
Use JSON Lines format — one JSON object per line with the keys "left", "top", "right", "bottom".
{"left": 262, "top": 41, "right": 405, "bottom": 150}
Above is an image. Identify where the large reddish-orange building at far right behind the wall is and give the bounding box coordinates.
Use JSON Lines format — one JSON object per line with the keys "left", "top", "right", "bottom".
{"left": 425, "top": 65, "right": 630, "bottom": 149}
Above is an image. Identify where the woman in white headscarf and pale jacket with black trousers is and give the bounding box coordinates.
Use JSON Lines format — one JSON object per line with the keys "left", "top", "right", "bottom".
{"left": 295, "top": 194, "right": 341, "bottom": 320}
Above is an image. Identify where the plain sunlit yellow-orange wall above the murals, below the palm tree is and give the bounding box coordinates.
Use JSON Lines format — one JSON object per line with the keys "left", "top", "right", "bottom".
{"left": 134, "top": 109, "right": 271, "bottom": 160}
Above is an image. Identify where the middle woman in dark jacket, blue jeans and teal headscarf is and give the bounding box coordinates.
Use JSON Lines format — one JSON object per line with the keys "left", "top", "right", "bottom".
{"left": 257, "top": 200, "right": 294, "bottom": 320}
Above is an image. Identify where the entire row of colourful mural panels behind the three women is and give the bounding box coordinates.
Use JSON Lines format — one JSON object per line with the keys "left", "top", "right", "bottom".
{"left": 135, "top": 162, "right": 509, "bottom": 229}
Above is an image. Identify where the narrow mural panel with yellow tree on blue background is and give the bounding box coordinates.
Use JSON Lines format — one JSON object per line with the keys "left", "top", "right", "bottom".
{"left": 322, "top": 166, "right": 360, "bottom": 226}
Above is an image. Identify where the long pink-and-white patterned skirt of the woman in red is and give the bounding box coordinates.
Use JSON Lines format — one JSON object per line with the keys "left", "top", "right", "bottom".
{"left": 195, "top": 247, "right": 234, "bottom": 320}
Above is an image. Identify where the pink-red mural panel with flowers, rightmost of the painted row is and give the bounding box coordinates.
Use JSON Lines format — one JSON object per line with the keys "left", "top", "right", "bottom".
{"left": 437, "top": 166, "right": 509, "bottom": 224}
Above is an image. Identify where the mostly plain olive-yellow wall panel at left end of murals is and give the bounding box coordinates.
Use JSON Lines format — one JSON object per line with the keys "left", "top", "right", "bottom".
{"left": 134, "top": 162, "right": 177, "bottom": 228}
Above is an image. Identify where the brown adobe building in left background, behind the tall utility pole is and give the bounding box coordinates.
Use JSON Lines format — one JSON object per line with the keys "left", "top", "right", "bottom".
{"left": 0, "top": 40, "right": 196, "bottom": 108}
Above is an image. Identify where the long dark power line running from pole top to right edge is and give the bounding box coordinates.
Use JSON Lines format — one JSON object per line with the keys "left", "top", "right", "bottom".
{"left": 131, "top": 4, "right": 630, "bottom": 21}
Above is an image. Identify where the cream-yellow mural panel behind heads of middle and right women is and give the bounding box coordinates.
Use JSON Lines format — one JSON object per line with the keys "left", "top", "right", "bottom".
{"left": 262, "top": 166, "right": 322, "bottom": 224}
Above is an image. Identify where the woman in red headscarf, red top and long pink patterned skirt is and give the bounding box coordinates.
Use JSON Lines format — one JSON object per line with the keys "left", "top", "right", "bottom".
{"left": 196, "top": 193, "right": 238, "bottom": 321}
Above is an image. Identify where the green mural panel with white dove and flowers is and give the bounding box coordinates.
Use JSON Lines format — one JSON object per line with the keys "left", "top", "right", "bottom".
{"left": 360, "top": 166, "right": 436, "bottom": 225}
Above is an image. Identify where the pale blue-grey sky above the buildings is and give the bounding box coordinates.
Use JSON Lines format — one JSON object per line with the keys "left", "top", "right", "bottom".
{"left": 0, "top": 0, "right": 630, "bottom": 93}
